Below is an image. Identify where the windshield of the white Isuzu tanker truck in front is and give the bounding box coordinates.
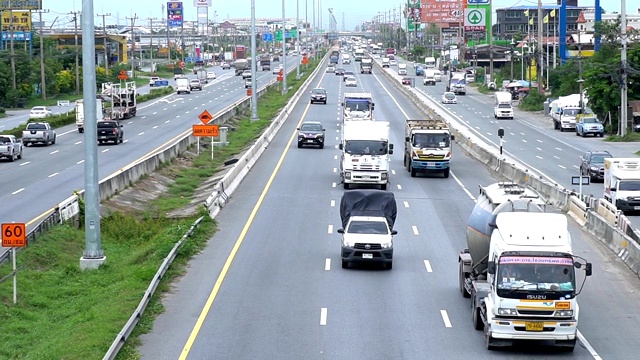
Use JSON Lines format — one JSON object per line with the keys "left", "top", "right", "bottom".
{"left": 496, "top": 256, "right": 576, "bottom": 296}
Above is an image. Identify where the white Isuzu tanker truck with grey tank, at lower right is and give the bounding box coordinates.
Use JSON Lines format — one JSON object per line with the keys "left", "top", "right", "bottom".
{"left": 458, "top": 183, "right": 592, "bottom": 352}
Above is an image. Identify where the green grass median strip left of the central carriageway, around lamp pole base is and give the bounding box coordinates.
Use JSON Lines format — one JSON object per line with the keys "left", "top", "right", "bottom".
{"left": 0, "top": 56, "right": 322, "bottom": 360}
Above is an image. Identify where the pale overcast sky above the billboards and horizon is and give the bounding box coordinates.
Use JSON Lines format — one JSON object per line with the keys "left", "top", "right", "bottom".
{"left": 43, "top": 0, "right": 640, "bottom": 31}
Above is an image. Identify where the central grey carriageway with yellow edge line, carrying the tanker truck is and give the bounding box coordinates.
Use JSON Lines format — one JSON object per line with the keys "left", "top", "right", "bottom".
{"left": 139, "top": 54, "right": 640, "bottom": 359}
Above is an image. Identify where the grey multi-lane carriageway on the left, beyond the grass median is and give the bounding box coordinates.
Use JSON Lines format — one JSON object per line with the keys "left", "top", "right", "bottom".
{"left": 0, "top": 57, "right": 295, "bottom": 253}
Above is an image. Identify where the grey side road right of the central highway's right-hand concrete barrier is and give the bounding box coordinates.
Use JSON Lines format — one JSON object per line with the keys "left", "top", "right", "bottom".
{"left": 393, "top": 57, "right": 640, "bottom": 228}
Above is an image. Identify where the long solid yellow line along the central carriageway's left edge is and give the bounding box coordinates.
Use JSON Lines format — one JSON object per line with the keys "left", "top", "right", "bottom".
{"left": 179, "top": 69, "right": 324, "bottom": 360}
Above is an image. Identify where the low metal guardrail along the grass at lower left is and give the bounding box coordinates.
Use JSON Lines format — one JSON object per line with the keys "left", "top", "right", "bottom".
{"left": 102, "top": 216, "right": 204, "bottom": 360}
